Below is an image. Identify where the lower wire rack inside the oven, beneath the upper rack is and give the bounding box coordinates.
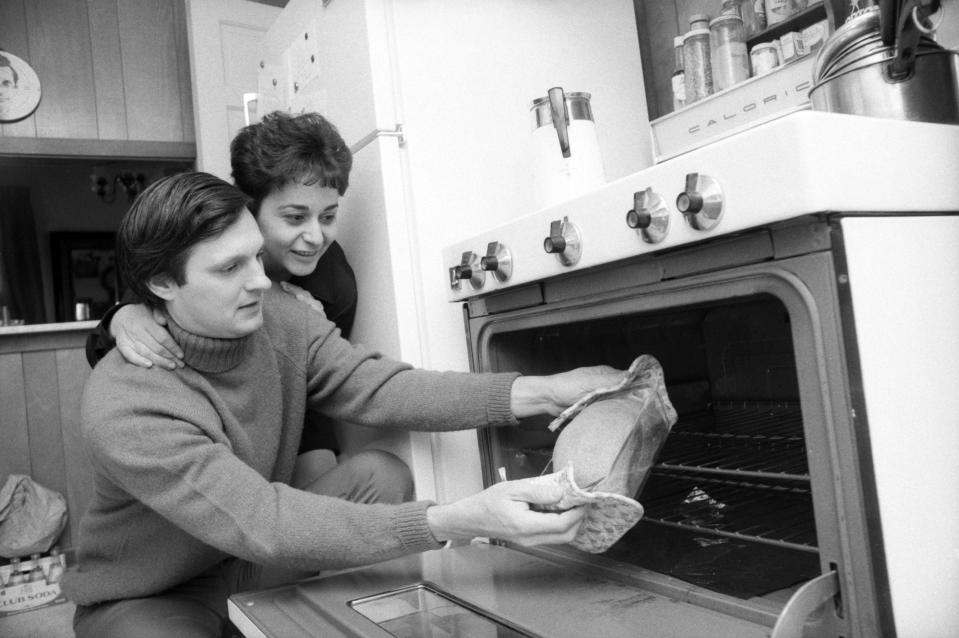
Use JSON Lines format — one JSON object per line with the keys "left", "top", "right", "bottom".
{"left": 638, "top": 468, "right": 818, "bottom": 552}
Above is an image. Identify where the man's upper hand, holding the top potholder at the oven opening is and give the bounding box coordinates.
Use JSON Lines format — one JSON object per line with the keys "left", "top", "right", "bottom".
{"left": 510, "top": 366, "right": 626, "bottom": 419}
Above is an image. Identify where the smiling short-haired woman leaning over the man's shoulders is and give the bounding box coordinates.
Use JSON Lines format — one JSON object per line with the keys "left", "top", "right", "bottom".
{"left": 87, "top": 111, "right": 357, "bottom": 460}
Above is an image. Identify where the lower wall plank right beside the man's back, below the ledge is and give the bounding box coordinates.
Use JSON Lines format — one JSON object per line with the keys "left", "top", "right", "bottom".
{"left": 56, "top": 348, "right": 93, "bottom": 547}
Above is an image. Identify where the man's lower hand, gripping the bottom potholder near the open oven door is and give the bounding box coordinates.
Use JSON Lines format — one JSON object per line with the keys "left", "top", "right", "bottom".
{"left": 426, "top": 477, "right": 586, "bottom": 545}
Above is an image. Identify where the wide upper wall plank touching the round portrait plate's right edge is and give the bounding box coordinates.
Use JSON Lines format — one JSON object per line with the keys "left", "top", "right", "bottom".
{"left": 26, "top": 0, "right": 97, "bottom": 139}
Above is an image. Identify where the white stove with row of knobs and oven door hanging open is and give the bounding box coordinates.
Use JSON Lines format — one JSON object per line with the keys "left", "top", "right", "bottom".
{"left": 230, "top": 112, "right": 959, "bottom": 638}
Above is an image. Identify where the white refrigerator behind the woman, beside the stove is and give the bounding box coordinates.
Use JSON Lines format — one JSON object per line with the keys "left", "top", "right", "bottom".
{"left": 263, "top": 0, "right": 651, "bottom": 500}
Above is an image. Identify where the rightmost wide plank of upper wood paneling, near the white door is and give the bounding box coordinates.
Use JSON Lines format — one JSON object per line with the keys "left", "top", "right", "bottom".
{"left": 118, "top": 0, "right": 183, "bottom": 141}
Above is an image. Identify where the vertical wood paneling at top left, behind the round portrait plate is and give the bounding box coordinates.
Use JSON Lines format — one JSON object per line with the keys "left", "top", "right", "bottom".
{"left": 0, "top": 0, "right": 195, "bottom": 158}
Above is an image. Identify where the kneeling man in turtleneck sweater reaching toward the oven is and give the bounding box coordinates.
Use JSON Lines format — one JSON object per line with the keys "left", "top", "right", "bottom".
{"left": 62, "top": 173, "right": 623, "bottom": 638}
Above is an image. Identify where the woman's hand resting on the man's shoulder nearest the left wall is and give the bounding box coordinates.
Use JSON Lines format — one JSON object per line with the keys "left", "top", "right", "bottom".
{"left": 110, "top": 304, "right": 183, "bottom": 370}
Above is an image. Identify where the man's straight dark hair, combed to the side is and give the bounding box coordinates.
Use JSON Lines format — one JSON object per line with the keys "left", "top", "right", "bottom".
{"left": 117, "top": 172, "right": 249, "bottom": 308}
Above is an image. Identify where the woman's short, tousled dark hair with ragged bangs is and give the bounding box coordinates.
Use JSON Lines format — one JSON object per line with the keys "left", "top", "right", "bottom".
{"left": 230, "top": 111, "right": 353, "bottom": 215}
